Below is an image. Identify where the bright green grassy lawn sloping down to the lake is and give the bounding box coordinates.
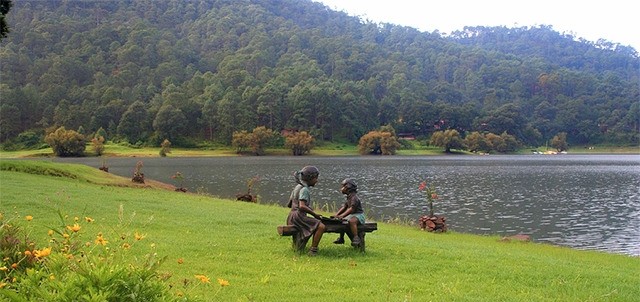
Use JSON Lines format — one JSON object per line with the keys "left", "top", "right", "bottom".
{"left": 0, "top": 160, "right": 640, "bottom": 301}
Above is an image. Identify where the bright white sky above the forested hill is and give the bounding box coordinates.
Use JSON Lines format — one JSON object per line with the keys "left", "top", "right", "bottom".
{"left": 314, "top": 0, "right": 640, "bottom": 52}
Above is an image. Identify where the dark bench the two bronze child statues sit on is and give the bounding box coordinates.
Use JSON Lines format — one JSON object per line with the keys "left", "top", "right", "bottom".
{"left": 278, "top": 219, "right": 378, "bottom": 253}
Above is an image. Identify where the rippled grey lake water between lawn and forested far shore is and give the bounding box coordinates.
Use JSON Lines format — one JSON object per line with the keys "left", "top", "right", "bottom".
{"left": 53, "top": 155, "right": 640, "bottom": 256}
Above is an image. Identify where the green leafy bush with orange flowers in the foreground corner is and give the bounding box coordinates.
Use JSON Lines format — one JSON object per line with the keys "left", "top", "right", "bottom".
{"left": 0, "top": 212, "right": 178, "bottom": 301}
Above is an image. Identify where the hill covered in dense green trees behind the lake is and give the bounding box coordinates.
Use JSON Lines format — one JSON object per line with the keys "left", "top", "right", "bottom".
{"left": 0, "top": 0, "right": 640, "bottom": 146}
